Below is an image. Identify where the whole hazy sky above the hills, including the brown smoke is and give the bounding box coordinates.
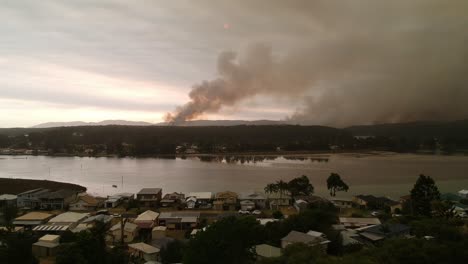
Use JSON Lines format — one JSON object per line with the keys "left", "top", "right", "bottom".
{"left": 0, "top": 0, "right": 468, "bottom": 127}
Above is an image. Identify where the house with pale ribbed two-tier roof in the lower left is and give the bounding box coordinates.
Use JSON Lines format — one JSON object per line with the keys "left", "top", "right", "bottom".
{"left": 33, "top": 212, "right": 89, "bottom": 233}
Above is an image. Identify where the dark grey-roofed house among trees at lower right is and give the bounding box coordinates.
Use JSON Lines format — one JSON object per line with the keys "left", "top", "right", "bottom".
{"left": 356, "top": 224, "right": 410, "bottom": 243}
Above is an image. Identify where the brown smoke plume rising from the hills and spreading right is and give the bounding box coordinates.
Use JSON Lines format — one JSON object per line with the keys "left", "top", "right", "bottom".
{"left": 167, "top": 0, "right": 468, "bottom": 126}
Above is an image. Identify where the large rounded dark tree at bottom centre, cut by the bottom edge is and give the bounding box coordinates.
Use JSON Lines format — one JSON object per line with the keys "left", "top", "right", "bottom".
{"left": 183, "top": 217, "right": 263, "bottom": 264}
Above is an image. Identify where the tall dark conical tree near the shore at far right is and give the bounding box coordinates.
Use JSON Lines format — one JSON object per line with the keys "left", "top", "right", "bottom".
{"left": 411, "top": 174, "right": 440, "bottom": 216}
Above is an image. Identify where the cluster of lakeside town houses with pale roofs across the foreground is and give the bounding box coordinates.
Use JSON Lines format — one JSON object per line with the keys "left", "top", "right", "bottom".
{"left": 0, "top": 174, "right": 468, "bottom": 264}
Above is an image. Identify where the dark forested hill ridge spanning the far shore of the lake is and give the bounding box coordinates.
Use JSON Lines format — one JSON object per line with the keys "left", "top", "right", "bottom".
{"left": 0, "top": 120, "right": 468, "bottom": 156}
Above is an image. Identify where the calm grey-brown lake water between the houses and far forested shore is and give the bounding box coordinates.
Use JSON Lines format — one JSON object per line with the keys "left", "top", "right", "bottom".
{"left": 0, "top": 154, "right": 468, "bottom": 198}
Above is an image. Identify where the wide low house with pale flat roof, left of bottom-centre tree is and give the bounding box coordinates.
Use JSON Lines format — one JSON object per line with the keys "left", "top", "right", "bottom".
{"left": 158, "top": 211, "right": 200, "bottom": 230}
